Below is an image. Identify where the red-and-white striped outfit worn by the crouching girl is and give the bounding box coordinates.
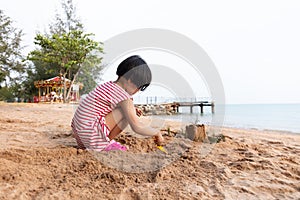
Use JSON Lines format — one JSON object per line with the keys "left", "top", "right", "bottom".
{"left": 71, "top": 81, "right": 131, "bottom": 151}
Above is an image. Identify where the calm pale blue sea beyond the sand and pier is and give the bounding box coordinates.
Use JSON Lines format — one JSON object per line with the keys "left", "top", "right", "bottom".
{"left": 151, "top": 104, "right": 300, "bottom": 134}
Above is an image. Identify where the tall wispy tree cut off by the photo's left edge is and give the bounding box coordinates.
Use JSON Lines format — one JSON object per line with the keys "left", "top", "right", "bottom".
{"left": 0, "top": 10, "right": 24, "bottom": 86}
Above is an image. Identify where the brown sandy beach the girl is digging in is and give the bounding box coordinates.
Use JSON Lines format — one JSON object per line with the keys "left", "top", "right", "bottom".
{"left": 0, "top": 103, "right": 300, "bottom": 200}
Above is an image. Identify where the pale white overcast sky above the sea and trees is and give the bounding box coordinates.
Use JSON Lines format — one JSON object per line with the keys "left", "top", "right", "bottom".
{"left": 0, "top": 0, "right": 300, "bottom": 104}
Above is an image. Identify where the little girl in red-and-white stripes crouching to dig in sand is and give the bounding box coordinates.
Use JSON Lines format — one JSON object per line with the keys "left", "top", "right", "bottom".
{"left": 71, "top": 55, "right": 164, "bottom": 151}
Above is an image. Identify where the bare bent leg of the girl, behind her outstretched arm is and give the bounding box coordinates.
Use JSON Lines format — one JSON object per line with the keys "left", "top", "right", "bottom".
{"left": 105, "top": 108, "right": 128, "bottom": 140}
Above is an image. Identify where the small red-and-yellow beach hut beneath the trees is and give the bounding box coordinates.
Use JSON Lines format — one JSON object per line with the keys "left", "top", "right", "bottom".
{"left": 34, "top": 76, "right": 83, "bottom": 102}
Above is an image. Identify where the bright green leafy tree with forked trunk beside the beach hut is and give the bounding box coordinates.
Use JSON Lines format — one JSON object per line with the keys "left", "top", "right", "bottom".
{"left": 28, "top": 30, "right": 103, "bottom": 102}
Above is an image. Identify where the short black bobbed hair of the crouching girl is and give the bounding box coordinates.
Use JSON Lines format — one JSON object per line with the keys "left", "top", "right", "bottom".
{"left": 116, "top": 55, "right": 152, "bottom": 91}
